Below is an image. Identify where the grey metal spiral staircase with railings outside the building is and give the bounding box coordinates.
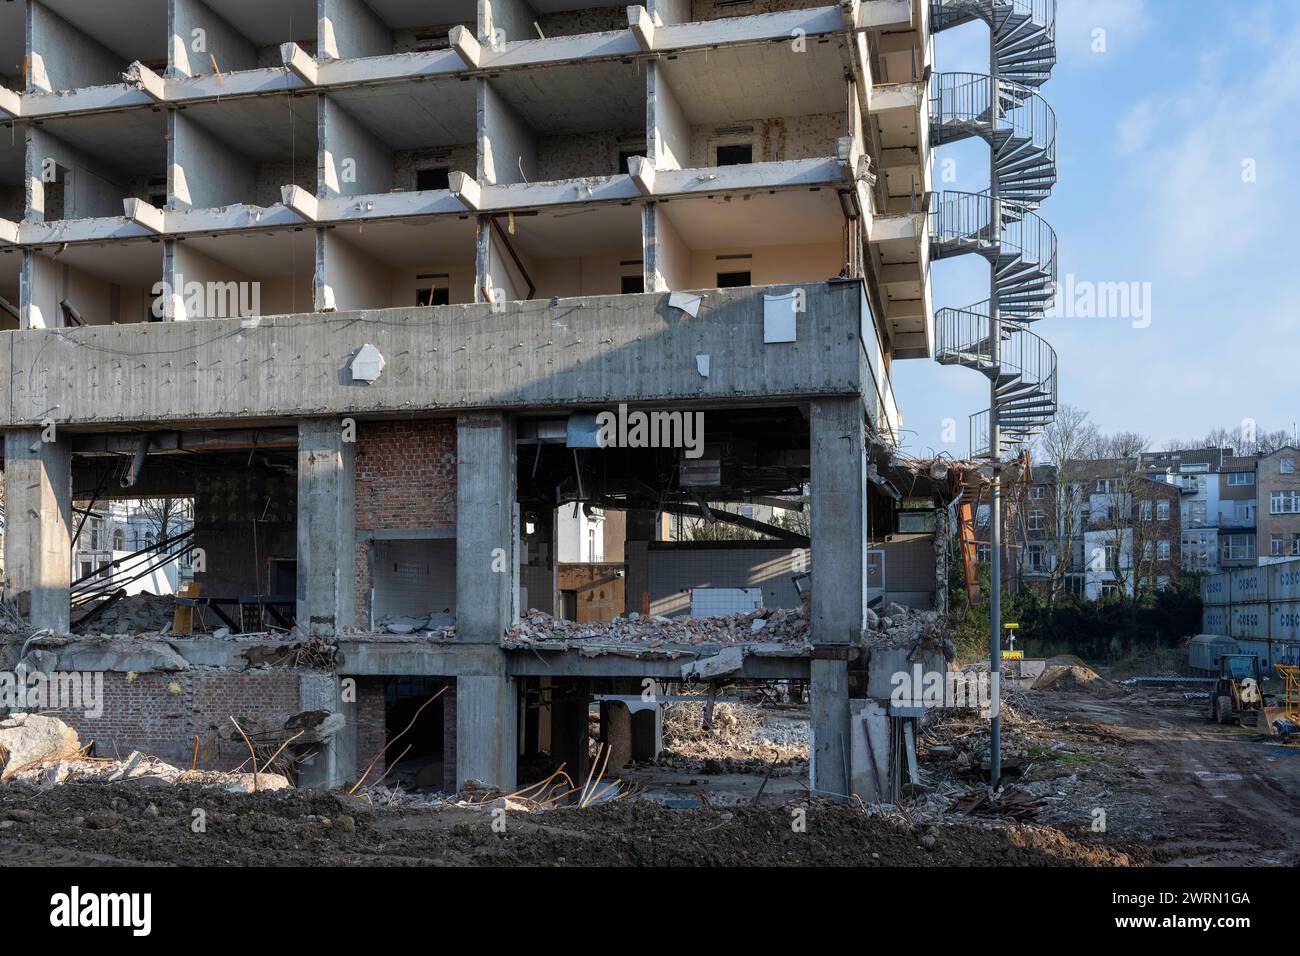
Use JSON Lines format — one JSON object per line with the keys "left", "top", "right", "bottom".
{"left": 930, "top": 0, "right": 1057, "bottom": 460}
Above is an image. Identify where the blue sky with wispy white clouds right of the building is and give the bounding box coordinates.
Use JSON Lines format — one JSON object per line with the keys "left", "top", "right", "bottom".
{"left": 894, "top": 0, "right": 1300, "bottom": 455}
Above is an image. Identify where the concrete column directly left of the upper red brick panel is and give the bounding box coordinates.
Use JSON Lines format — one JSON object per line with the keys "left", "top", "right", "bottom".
{"left": 298, "top": 419, "right": 356, "bottom": 636}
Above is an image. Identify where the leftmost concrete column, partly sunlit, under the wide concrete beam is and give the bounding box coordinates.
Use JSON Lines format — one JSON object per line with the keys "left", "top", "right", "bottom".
{"left": 4, "top": 427, "right": 74, "bottom": 633}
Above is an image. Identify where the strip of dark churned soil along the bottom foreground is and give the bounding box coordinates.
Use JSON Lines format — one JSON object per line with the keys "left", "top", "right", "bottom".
{"left": 0, "top": 784, "right": 1143, "bottom": 866}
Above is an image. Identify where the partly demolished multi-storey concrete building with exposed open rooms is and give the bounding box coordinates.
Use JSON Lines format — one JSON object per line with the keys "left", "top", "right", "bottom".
{"left": 0, "top": 0, "right": 946, "bottom": 796}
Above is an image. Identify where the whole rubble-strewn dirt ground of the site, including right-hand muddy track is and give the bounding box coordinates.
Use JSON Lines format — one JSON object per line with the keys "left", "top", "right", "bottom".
{"left": 0, "top": 682, "right": 1300, "bottom": 866}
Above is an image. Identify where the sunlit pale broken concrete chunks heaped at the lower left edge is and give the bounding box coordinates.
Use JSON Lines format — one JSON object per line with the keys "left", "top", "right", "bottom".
{"left": 0, "top": 713, "right": 290, "bottom": 793}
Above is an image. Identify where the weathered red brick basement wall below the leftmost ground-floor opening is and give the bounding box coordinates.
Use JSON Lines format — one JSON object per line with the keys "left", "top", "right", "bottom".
{"left": 59, "top": 670, "right": 302, "bottom": 770}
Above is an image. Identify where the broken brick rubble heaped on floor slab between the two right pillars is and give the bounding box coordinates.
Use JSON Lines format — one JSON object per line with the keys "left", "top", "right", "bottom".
{"left": 502, "top": 607, "right": 809, "bottom": 646}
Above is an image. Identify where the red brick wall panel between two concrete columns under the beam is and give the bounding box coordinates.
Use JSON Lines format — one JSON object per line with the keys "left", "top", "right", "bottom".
{"left": 356, "top": 421, "right": 456, "bottom": 627}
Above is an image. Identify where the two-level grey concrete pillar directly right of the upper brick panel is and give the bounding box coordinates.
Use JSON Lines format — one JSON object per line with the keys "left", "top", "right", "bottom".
{"left": 456, "top": 412, "right": 519, "bottom": 791}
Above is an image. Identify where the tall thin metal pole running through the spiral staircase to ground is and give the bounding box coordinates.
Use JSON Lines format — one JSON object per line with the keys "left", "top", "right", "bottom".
{"left": 988, "top": 17, "right": 1002, "bottom": 787}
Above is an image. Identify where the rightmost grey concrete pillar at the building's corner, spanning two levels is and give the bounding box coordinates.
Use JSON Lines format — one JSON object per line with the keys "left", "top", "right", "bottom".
{"left": 809, "top": 398, "right": 867, "bottom": 799}
